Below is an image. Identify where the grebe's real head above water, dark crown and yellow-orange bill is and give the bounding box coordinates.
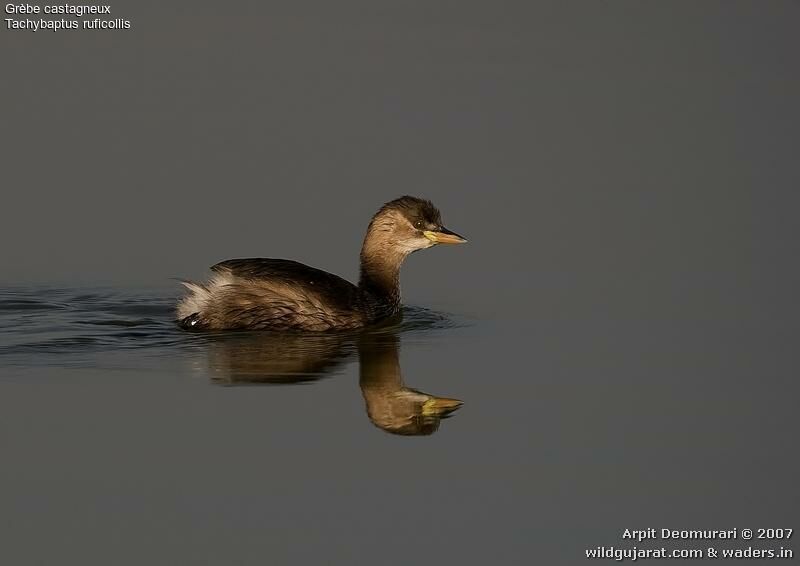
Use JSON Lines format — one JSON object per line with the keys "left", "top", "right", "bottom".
{"left": 364, "top": 196, "right": 467, "bottom": 256}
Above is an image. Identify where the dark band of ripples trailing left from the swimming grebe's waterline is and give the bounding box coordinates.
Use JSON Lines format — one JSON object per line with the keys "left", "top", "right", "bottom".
{"left": 0, "top": 288, "right": 466, "bottom": 375}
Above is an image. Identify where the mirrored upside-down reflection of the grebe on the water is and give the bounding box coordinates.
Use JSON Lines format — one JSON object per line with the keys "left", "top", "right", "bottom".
{"left": 203, "top": 325, "right": 462, "bottom": 435}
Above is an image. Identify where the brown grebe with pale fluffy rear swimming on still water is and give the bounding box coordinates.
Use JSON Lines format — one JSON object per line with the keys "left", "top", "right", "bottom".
{"left": 176, "top": 195, "right": 467, "bottom": 331}
